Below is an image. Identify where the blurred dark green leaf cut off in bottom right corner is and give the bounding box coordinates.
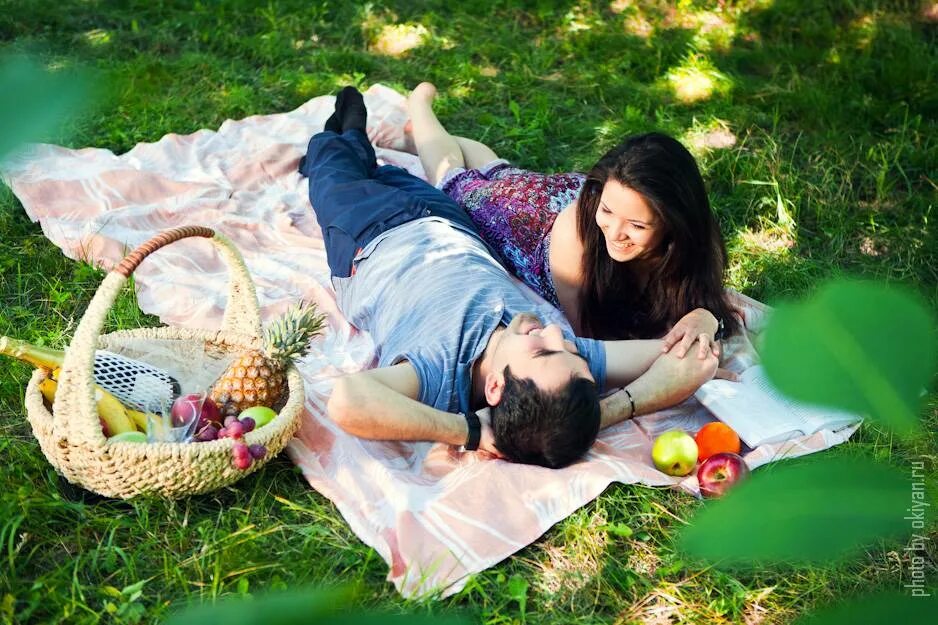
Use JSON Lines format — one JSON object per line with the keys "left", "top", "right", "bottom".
{"left": 795, "top": 588, "right": 938, "bottom": 625}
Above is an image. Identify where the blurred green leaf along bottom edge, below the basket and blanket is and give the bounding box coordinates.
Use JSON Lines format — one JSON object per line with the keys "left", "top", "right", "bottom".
{"left": 164, "top": 587, "right": 469, "bottom": 625}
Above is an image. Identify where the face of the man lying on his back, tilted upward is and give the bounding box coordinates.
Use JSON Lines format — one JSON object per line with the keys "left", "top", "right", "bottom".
{"left": 486, "top": 313, "right": 594, "bottom": 405}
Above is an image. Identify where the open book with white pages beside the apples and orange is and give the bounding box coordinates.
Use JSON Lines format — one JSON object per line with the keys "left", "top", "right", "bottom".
{"left": 694, "top": 365, "right": 862, "bottom": 447}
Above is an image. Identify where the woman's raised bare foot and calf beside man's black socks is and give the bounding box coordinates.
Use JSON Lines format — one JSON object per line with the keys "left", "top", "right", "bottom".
{"left": 407, "top": 82, "right": 466, "bottom": 185}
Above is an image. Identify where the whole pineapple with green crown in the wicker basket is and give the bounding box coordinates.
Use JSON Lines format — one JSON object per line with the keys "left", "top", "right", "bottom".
{"left": 211, "top": 302, "right": 324, "bottom": 417}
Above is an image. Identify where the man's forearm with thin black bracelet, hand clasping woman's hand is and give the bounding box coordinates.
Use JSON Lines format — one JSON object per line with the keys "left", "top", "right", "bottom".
{"left": 600, "top": 347, "right": 718, "bottom": 428}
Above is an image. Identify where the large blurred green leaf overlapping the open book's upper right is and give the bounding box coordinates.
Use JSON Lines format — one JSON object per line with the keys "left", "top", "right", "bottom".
{"left": 762, "top": 281, "right": 936, "bottom": 434}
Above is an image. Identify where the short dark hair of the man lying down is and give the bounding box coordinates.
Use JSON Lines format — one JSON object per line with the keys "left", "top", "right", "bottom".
{"left": 491, "top": 367, "right": 599, "bottom": 469}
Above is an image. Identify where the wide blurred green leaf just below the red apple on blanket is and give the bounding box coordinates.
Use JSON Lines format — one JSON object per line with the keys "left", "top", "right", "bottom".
{"left": 678, "top": 456, "right": 912, "bottom": 567}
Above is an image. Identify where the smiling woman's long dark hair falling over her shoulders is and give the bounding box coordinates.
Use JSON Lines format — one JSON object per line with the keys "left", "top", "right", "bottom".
{"left": 577, "top": 132, "right": 739, "bottom": 339}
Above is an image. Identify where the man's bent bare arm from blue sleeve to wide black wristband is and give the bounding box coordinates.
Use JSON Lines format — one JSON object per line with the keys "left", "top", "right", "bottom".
{"left": 328, "top": 362, "right": 468, "bottom": 445}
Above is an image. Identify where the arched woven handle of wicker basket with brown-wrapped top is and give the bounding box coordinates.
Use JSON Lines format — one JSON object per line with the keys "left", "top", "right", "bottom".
{"left": 52, "top": 226, "right": 264, "bottom": 446}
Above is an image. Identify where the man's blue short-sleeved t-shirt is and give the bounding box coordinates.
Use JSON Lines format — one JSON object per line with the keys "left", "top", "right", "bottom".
{"left": 333, "top": 217, "right": 606, "bottom": 414}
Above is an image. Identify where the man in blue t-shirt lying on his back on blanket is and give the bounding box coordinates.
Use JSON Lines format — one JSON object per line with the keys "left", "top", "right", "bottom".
{"left": 300, "top": 87, "right": 717, "bottom": 467}
